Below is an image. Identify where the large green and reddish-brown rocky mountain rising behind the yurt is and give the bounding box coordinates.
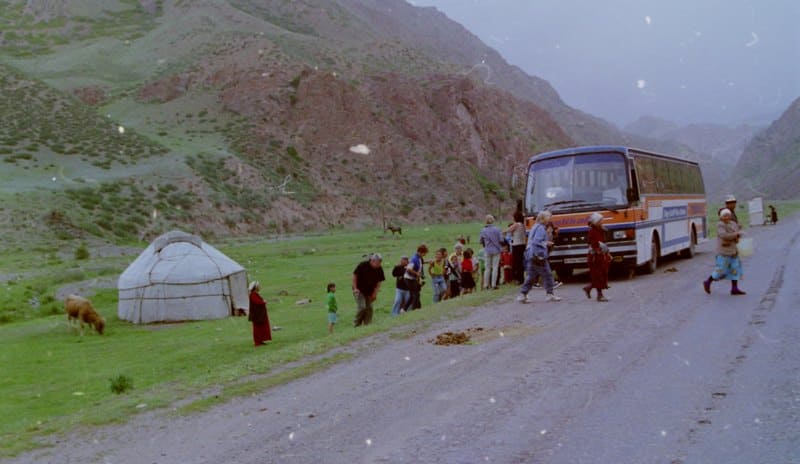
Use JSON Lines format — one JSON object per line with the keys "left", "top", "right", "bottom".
{"left": 0, "top": 0, "right": 686, "bottom": 246}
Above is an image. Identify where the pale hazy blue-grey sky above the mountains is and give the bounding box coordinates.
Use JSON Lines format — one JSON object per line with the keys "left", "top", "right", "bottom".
{"left": 409, "top": 0, "right": 800, "bottom": 126}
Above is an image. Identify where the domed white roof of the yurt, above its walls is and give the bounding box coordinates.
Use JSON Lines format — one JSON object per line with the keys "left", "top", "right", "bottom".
{"left": 117, "top": 230, "right": 244, "bottom": 289}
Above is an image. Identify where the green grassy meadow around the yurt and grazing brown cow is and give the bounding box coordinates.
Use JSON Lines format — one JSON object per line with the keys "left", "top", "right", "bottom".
{"left": 0, "top": 224, "right": 506, "bottom": 456}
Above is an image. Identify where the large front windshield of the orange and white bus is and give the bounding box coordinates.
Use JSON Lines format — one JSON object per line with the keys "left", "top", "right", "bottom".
{"left": 525, "top": 153, "right": 628, "bottom": 214}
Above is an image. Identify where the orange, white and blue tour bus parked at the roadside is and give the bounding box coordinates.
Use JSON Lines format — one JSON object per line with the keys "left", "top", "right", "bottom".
{"left": 525, "top": 146, "right": 708, "bottom": 278}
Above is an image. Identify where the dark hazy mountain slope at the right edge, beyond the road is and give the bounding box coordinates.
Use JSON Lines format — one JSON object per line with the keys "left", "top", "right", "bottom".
{"left": 733, "top": 98, "right": 800, "bottom": 200}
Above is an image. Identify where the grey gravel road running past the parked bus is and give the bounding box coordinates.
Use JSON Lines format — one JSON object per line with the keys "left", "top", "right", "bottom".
{"left": 9, "top": 217, "right": 800, "bottom": 464}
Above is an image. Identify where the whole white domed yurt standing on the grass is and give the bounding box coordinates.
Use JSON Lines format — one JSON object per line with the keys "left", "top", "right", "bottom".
{"left": 117, "top": 230, "right": 249, "bottom": 324}
